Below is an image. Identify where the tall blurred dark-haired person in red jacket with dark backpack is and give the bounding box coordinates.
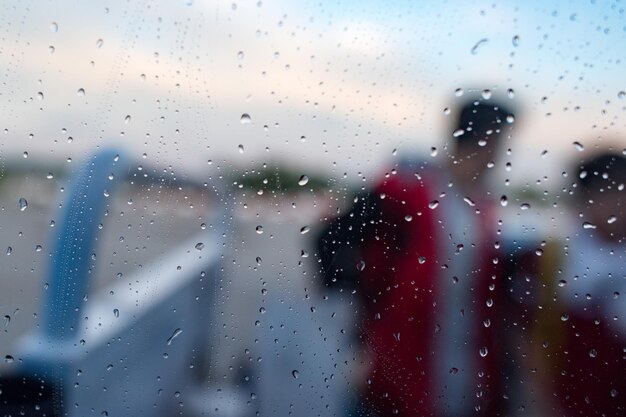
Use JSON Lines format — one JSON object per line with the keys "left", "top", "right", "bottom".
{"left": 318, "top": 97, "right": 514, "bottom": 416}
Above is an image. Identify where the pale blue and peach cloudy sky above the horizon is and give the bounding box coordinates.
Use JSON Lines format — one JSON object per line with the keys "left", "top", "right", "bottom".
{"left": 0, "top": 0, "right": 626, "bottom": 185}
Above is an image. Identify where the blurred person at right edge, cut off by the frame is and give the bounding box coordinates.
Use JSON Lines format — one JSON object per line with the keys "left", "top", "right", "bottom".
{"left": 535, "top": 151, "right": 626, "bottom": 416}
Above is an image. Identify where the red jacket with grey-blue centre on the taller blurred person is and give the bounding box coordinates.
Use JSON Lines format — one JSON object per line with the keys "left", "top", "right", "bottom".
{"left": 359, "top": 170, "right": 503, "bottom": 416}
